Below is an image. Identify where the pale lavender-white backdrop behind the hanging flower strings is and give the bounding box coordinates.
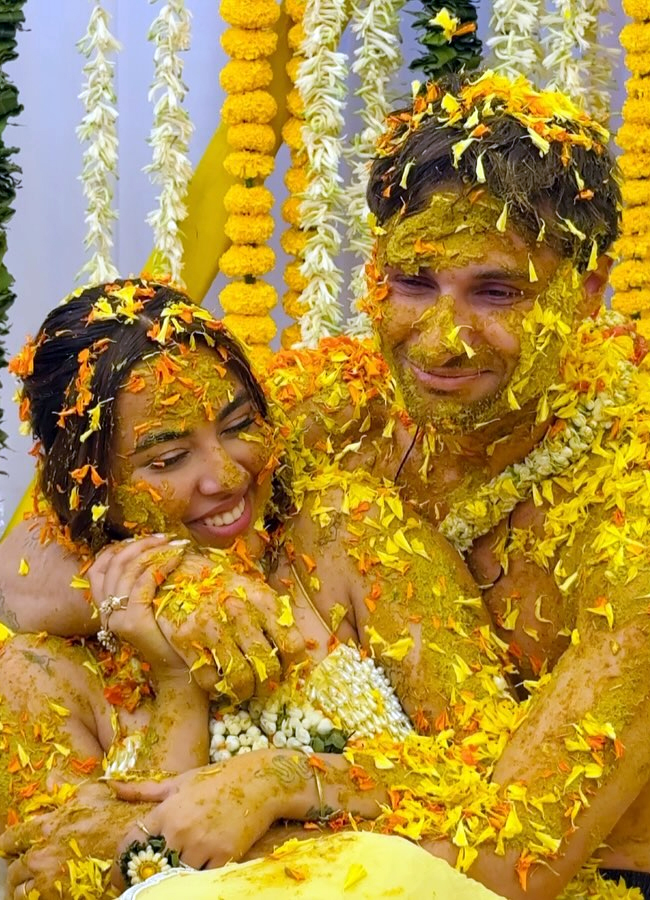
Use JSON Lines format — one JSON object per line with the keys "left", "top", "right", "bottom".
{"left": 0, "top": 0, "right": 624, "bottom": 529}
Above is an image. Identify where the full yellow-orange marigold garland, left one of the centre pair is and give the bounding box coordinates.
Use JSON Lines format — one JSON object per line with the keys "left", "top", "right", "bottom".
{"left": 219, "top": 0, "right": 280, "bottom": 367}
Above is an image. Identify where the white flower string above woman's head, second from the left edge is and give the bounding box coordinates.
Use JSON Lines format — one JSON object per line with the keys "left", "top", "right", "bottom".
{"left": 144, "top": 0, "right": 193, "bottom": 284}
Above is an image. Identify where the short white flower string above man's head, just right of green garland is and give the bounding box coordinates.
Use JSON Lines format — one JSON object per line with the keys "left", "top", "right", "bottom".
{"left": 487, "top": 0, "right": 542, "bottom": 81}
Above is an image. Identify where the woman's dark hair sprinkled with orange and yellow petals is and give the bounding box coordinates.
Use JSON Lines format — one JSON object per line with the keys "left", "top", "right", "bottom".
{"left": 22, "top": 279, "right": 289, "bottom": 550}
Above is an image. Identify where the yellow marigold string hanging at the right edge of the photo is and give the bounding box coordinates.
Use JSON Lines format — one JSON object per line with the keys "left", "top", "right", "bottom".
{"left": 611, "top": 0, "right": 650, "bottom": 338}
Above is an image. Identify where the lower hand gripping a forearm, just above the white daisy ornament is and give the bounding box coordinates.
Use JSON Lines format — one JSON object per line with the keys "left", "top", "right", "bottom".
{"left": 111, "top": 750, "right": 296, "bottom": 869}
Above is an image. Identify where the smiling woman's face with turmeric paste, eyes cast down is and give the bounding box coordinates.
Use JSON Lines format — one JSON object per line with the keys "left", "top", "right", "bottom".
{"left": 109, "top": 346, "right": 272, "bottom": 556}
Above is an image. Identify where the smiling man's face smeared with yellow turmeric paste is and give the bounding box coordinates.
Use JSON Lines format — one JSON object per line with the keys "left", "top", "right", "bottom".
{"left": 377, "top": 193, "right": 582, "bottom": 430}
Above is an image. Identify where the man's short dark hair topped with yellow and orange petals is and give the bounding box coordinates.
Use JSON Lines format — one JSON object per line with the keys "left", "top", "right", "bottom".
{"left": 368, "top": 73, "right": 621, "bottom": 269}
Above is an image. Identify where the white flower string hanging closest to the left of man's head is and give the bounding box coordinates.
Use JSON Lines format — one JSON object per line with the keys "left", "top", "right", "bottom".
{"left": 344, "top": 0, "right": 404, "bottom": 338}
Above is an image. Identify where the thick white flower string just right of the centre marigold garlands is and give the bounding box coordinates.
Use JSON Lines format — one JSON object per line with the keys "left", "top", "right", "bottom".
{"left": 296, "top": 0, "right": 348, "bottom": 347}
